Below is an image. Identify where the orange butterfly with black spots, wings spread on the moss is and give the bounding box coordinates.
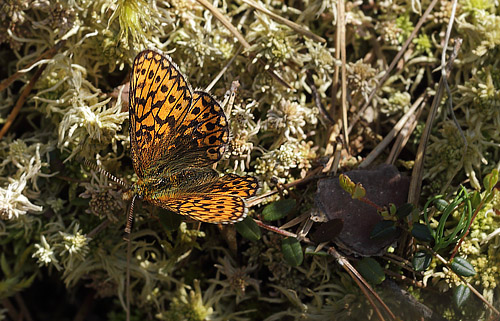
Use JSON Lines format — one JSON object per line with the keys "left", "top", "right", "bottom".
{"left": 127, "top": 50, "right": 258, "bottom": 225}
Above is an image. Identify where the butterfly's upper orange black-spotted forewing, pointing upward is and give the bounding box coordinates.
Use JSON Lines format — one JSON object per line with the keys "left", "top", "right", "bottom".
{"left": 129, "top": 50, "right": 193, "bottom": 177}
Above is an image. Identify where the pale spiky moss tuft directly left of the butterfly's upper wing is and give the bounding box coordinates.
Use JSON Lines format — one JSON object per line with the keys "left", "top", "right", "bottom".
{"left": 35, "top": 57, "right": 128, "bottom": 158}
